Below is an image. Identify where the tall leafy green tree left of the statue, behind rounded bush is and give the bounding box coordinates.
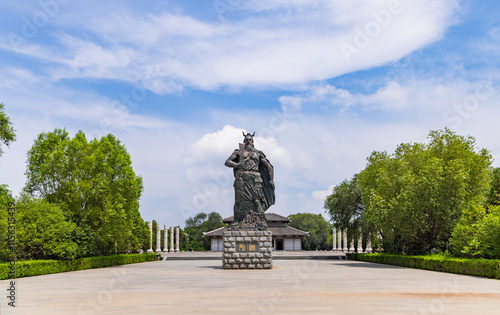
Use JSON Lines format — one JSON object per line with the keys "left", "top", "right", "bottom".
{"left": 24, "top": 129, "right": 149, "bottom": 256}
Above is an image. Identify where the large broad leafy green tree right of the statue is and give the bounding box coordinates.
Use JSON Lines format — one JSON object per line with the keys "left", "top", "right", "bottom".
{"left": 359, "top": 129, "right": 491, "bottom": 253}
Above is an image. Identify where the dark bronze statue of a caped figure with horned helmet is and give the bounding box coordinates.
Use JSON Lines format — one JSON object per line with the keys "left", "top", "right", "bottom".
{"left": 225, "top": 132, "right": 275, "bottom": 230}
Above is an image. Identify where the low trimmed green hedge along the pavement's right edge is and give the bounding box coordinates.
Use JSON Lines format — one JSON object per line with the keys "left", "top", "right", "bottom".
{"left": 351, "top": 254, "right": 500, "bottom": 279}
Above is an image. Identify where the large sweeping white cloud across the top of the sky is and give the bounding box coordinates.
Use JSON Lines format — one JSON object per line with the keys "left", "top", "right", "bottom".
{"left": 2, "top": 0, "right": 457, "bottom": 93}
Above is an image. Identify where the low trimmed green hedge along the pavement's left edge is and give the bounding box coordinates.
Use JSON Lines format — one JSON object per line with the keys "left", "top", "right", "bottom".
{"left": 0, "top": 253, "right": 156, "bottom": 280}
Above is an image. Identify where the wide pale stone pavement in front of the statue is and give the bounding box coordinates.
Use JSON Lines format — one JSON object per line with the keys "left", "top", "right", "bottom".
{"left": 0, "top": 260, "right": 500, "bottom": 315}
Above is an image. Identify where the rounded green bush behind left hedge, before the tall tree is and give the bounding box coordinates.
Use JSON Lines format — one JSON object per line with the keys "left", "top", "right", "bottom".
{"left": 16, "top": 195, "right": 78, "bottom": 259}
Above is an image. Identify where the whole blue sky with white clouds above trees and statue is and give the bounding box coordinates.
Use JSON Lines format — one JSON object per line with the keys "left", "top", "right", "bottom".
{"left": 0, "top": 0, "right": 500, "bottom": 226}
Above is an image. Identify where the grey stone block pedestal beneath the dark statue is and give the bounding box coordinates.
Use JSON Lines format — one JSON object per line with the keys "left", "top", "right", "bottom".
{"left": 222, "top": 231, "right": 273, "bottom": 269}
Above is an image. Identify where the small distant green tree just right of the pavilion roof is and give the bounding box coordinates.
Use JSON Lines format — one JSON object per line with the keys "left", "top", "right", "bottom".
{"left": 288, "top": 213, "right": 331, "bottom": 250}
